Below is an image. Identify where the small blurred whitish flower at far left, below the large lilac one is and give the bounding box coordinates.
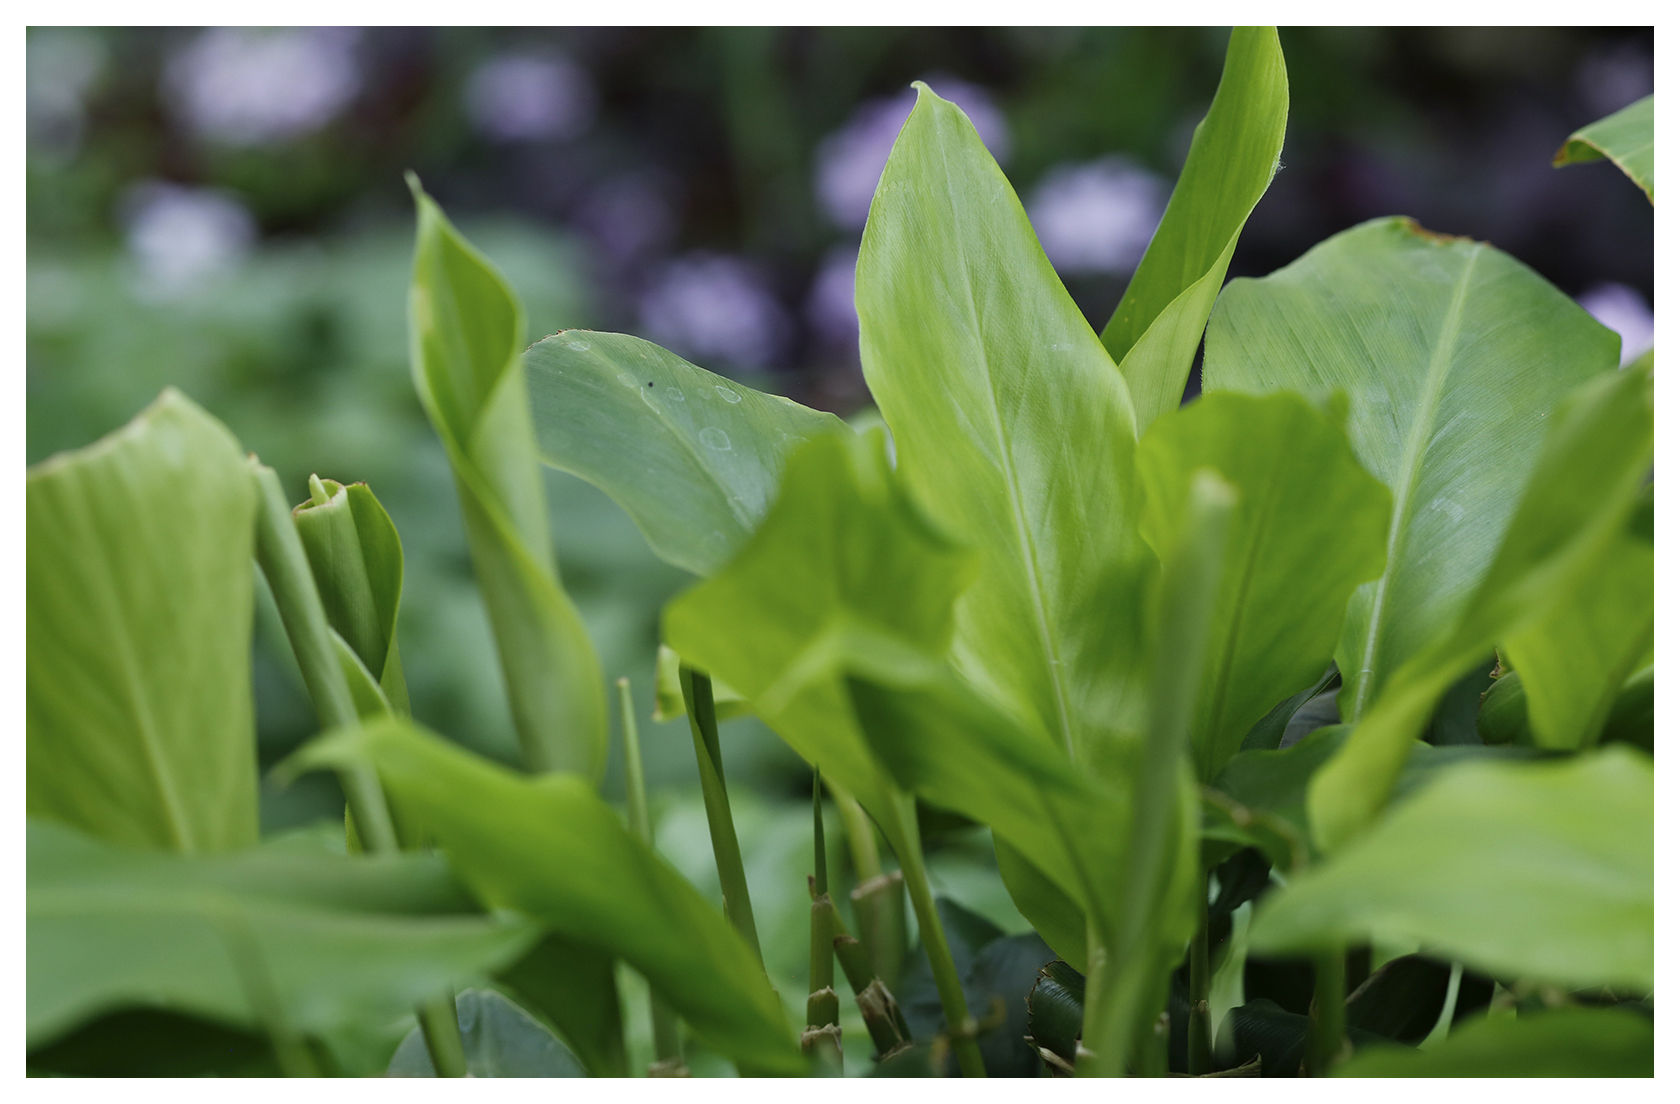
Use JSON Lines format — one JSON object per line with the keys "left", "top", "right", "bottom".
{"left": 123, "top": 180, "right": 257, "bottom": 299}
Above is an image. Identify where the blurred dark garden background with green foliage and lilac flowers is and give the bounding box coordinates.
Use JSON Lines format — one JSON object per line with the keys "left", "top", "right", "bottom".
{"left": 27, "top": 29, "right": 1653, "bottom": 1070}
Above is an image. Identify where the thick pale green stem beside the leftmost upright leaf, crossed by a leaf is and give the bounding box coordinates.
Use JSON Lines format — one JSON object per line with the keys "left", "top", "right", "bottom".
{"left": 250, "top": 457, "right": 396, "bottom": 852}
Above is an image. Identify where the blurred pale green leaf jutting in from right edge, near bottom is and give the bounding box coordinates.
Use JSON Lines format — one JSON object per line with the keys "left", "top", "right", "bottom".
{"left": 1248, "top": 746, "right": 1653, "bottom": 991}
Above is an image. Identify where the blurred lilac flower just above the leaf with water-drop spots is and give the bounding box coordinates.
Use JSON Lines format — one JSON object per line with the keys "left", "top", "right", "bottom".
{"left": 642, "top": 254, "right": 788, "bottom": 368}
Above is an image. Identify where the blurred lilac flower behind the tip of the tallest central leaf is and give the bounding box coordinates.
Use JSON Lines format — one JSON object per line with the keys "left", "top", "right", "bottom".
{"left": 816, "top": 77, "right": 1010, "bottom": 230}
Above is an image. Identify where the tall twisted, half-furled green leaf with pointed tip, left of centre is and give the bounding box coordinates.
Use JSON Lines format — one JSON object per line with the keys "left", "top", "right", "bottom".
{"left": 408, "top": 176, "right": 606, "bottom": 781}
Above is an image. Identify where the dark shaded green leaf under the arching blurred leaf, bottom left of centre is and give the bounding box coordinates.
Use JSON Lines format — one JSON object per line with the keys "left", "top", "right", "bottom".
{"left": 496, "top": 933, "right": 630, "bottom": 1077}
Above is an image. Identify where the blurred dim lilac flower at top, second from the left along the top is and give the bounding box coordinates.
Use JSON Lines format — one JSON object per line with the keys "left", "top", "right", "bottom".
{"left": 465, "top": 52, "right": 595, "bottom": 141}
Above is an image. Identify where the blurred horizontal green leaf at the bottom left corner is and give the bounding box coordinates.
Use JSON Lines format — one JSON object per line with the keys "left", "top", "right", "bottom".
{"left": 29, "top": 822, "right": 538, "bottom": 1064}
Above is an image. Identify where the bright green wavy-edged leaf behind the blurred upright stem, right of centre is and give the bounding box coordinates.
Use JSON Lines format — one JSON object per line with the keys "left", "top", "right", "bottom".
{"left": 1137, "top": 393, "right": 1389, "bottom": 781}
